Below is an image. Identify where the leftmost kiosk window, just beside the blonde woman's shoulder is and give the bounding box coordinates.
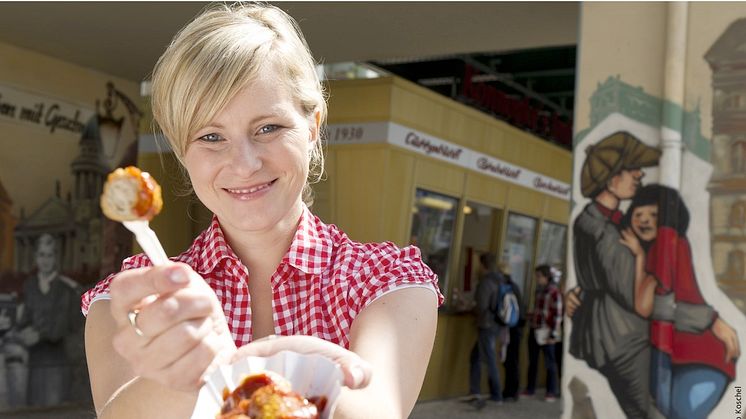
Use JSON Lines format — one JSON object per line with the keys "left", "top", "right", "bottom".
{"left": 409, "top": 189, "right": 458, "bottom": 295}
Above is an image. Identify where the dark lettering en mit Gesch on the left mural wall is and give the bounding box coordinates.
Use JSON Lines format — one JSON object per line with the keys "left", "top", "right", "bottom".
{"left": 0, "top": 85, "right": 95, "bottom": 138}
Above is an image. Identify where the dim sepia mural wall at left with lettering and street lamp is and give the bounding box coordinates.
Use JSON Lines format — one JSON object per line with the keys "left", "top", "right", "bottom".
{"left": 0, "top": 43, "right": 139, "bottom": 416}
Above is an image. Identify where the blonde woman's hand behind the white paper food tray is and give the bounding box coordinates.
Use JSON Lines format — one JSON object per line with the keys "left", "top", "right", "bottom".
{"left": 231, "top": 335, "right": 372, "bottom": 389}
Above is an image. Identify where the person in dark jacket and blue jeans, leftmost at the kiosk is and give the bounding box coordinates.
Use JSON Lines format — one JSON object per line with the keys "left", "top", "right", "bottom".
{"left": 465, "top": 253, "right": 503, "bottom": 407}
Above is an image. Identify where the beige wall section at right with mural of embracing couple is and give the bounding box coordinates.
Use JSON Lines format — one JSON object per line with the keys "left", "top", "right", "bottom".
{"left": 563, "top": 3, "right": 746, "bottom": 418}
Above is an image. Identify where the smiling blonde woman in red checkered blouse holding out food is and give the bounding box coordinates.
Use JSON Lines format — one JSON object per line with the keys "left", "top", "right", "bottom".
{"left": 82, "top": 3, "right": 443, "bottom": 418}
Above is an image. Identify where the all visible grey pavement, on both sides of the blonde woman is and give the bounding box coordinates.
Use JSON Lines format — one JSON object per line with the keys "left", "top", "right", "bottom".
{"left": 0, "top": 399, "right": 562, "bottom": 419}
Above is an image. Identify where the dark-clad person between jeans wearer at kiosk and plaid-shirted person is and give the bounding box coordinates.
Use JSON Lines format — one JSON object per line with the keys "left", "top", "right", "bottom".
{"left": 500, "top": 264, "right": 526, "bottom": 401}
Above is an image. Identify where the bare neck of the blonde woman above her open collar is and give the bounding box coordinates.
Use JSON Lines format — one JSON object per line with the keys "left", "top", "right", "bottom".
{"left": 221, "top": 202, "right": 303, "bottom": 274}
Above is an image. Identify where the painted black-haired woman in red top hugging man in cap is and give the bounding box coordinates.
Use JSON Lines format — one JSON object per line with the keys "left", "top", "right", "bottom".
{"left": 622, "top": 185, "right": 740, "bottom": 419}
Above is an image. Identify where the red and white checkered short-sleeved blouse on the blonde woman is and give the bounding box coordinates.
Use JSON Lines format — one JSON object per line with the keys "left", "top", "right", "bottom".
{"left": 81, "top": 208, "right": 443, "bottom": 348}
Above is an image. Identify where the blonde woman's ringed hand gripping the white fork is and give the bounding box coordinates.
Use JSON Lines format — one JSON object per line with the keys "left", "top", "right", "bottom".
{"left": 111, "top": 264, "right": 236, "bottom": 391}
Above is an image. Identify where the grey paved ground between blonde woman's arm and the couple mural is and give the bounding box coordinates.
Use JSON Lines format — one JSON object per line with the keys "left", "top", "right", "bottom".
{"left": 409, "top": 399, "right": 562, "bottom": 419}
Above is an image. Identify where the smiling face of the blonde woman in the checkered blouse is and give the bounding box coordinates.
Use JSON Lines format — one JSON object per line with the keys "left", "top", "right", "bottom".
{"left": 184, "top": 70, "right": 319, "bottom": 238}
